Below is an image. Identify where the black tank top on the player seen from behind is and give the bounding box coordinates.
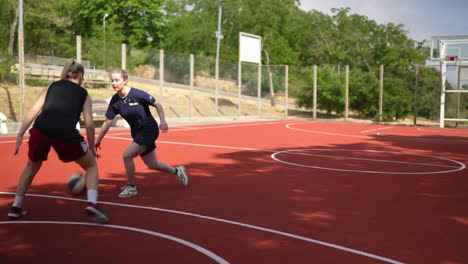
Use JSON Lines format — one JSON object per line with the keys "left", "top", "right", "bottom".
{"left": 34, "top": 80, "right": 88, "bottom": 142}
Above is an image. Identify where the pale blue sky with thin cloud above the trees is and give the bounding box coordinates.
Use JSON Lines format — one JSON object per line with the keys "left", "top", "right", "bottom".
{"left": 300, "top": 0, "right": 468, "bottom": 41}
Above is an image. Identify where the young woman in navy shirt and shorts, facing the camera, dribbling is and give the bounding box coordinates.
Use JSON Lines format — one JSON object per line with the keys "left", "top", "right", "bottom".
{"left": 96, "top": 69, "right": 188, "bottom": 198}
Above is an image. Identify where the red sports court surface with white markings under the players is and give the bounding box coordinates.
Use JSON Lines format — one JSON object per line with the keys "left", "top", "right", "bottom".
{"left": 0, "top": 120, "right": 468, "bottom": 264}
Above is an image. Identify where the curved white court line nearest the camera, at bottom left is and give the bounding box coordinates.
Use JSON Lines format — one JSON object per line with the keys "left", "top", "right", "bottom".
{"left": 0, "top": 221, "right": 229, "bottom": 264}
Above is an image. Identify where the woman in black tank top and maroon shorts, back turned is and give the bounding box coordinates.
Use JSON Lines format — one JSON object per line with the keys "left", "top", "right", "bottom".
{"left": 8, "top": 60, "right": 108, "bottom": 224}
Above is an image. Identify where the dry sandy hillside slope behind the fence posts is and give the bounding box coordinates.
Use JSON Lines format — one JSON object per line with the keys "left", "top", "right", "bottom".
{"left": 0, "top": 78, "right": 311, "bottom": 129}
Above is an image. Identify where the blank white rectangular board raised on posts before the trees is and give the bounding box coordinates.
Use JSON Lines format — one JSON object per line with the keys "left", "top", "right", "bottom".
{"left": 239, "top": 32, "right": 262, "bottom": 64}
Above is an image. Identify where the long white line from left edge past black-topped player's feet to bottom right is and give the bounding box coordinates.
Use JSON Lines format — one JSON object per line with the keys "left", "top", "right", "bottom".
{"left": 0, "top": 192, "right": 403, "bottom": 264}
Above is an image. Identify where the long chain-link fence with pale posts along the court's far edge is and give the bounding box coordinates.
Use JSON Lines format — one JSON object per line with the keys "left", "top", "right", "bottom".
{"left": 0, "top": 35, "right": 468, "bottom": 133}
